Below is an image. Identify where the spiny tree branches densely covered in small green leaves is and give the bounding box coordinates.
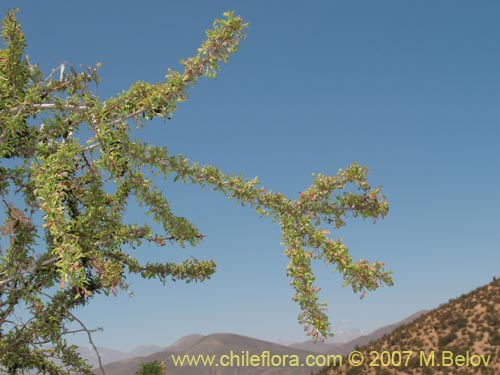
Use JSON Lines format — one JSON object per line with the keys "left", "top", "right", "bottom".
{"left": 0, "top": 10, "right": 392, "bottom": 374}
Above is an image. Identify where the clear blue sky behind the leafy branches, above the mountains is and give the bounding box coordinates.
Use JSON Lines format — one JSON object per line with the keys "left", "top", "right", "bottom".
{"left": 0, "top": 0, "right": 500, "bottom": 350}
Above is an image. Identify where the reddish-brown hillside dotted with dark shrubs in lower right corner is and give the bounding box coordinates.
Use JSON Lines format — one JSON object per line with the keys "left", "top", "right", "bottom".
{"left": 318, "top": 279, "right": 500, "bottom": 375}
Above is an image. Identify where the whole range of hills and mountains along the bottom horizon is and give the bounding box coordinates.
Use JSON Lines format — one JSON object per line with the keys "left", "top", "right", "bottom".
{"left": 91, "top": 278, "right": 500, "bottom": 375}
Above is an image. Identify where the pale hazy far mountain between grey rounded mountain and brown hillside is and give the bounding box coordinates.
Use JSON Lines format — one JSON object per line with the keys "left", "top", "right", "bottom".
{"left": 290, "top": 310, "right": 427, "bottom": 355}
